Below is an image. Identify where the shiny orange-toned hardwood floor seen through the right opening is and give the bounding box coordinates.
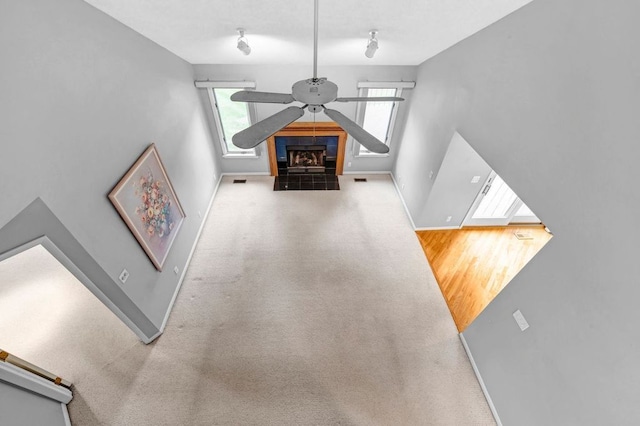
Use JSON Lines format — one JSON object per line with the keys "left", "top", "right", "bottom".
{"left": 416, "top": 225, "right": 552, "bottom": 332}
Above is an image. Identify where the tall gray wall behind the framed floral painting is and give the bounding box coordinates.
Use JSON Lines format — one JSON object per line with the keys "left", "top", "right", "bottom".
{"left": 0, "top": 0, "right": 220, "bottom": 336}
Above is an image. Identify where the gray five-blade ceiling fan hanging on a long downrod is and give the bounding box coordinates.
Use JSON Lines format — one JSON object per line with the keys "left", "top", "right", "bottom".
{"left": 231, "top": 0, "right": 404, "bottom": 154}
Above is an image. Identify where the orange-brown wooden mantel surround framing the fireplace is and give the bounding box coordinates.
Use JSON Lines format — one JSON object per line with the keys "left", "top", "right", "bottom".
{"left": 267, "top": 121, "right": 347, "bottom": 176}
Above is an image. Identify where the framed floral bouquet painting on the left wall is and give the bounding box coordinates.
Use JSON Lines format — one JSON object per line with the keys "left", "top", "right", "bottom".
{"left": 109, "top": 144, "right": 185, "bottom": 271}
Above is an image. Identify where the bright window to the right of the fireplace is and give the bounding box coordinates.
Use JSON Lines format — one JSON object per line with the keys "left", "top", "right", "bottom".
{"left": 353, "top": 82, "right": 415, "bottom": 157}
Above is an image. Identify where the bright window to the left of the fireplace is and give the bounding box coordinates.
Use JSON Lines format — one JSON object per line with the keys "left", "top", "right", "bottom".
{"left": 196, "top": 81, "right": 258, "bottom": 158}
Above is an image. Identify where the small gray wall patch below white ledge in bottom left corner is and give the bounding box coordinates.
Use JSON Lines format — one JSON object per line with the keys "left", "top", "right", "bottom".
{"left": 0, "top": 380, "right": 65, "bottom": 426}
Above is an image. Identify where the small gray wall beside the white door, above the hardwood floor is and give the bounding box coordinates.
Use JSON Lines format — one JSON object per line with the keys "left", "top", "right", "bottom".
{"left": 414, "top": 132, "right": 491, "bottom": 228}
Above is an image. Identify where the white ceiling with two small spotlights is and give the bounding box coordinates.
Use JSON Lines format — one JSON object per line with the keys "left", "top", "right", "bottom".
{"left": 85, "top": 0, "right": 531, "bottom": 65}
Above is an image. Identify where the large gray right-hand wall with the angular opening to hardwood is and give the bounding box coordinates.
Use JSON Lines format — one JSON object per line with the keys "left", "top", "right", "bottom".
{"left": 396, "top": 0, "right": 640, "bottom": 425}
